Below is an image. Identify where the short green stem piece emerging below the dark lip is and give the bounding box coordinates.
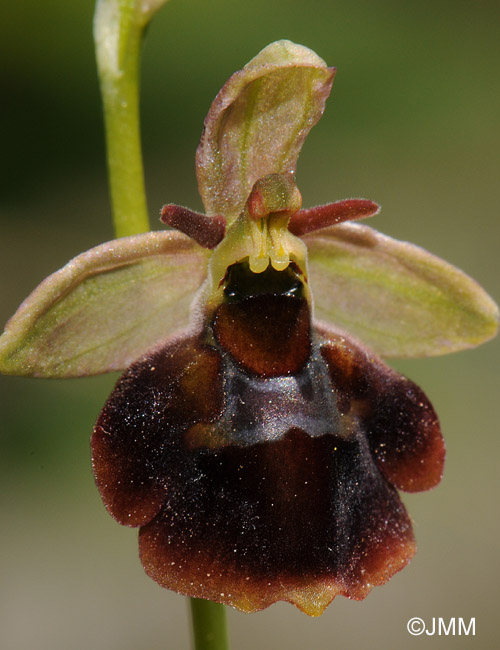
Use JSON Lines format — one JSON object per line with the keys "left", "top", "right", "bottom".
{"left": 190, "top": 598, "right": 229, "bottom": 650}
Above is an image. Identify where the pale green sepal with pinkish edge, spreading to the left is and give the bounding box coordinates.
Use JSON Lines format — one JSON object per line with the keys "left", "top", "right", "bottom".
{"left": 0, "top": 231, "right": 207, "bottom": 377}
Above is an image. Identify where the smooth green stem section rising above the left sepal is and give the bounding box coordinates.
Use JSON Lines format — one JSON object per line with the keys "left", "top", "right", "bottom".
{"left": 94, "top": 0, "right": 149, "bottom": 237}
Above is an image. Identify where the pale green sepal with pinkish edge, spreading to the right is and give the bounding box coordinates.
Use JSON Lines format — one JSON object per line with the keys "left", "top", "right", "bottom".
{"left": 304, "top": 223, "right": 499, "bottom": 357}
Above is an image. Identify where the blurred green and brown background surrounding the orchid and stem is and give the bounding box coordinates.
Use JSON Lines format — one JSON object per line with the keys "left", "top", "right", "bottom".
{"left": 0, "top": 0, "right": 500, "bottom": 650}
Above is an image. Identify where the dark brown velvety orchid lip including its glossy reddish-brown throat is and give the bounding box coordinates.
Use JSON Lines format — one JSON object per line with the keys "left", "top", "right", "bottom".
{"left": 92, "top": 263, "right": 444, "bottom": 615}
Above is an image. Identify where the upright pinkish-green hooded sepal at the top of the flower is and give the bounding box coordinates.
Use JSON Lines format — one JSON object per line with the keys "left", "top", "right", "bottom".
{"left": 196, "top": 40, "right": 335, "bottom": 221}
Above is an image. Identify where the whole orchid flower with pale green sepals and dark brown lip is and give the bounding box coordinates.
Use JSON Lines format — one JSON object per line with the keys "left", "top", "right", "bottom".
{"left": 0, "top": 41, "right": 498, "bottom": 615}
